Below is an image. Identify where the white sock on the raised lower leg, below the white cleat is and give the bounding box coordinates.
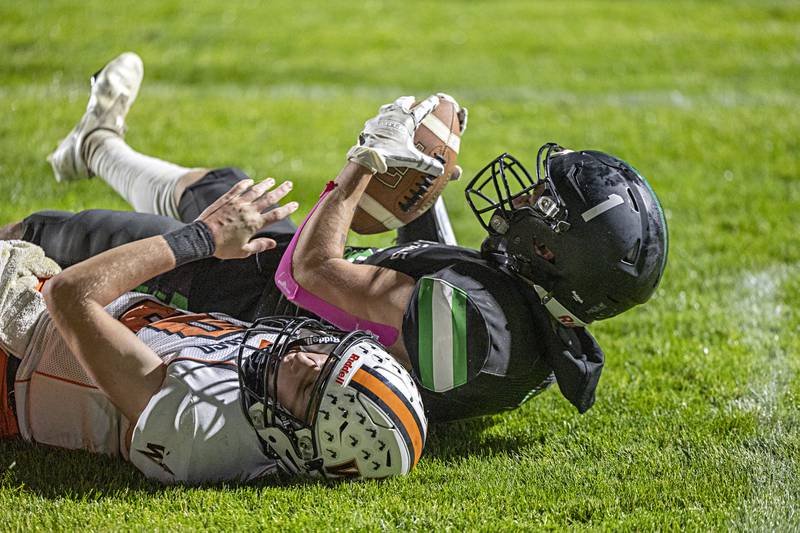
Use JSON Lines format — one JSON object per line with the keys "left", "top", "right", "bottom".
{"left": 83, "top": 130, "right": 192, "bottom": 219}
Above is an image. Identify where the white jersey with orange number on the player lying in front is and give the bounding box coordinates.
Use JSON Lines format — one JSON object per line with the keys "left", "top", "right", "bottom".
{"left": 15, "top": 293, "right": 275, "bottom": 483}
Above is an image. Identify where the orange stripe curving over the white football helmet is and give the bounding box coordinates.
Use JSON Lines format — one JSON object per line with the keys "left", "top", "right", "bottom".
{"left": 350, "top": 368, "right": 425, "bottom": 466}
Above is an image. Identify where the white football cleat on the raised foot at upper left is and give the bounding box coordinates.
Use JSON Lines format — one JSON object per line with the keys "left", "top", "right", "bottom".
{"left": 47, "top": 52, "right": 144, "bottom": 181}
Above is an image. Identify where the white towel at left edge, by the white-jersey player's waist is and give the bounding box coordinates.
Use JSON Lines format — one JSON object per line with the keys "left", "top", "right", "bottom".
{"left": 0, "top": 241, "right": 61, "bottom": 357}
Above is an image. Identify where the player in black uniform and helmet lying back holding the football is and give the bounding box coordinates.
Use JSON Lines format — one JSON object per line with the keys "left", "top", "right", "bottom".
{"left": 6, "top": 52, "right": 667, "bottom": 421}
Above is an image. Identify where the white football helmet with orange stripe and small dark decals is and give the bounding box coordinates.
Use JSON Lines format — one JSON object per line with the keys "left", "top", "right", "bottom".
{"left": 238, "top": 317, "right": 427, "bottom": 478}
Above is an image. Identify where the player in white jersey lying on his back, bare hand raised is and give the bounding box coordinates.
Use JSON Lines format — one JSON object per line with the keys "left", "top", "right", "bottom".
{"left": 0, "top": 174, "right": 427, "bottom": 483}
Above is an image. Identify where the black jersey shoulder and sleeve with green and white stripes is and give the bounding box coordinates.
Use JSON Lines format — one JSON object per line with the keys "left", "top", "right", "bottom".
{"left": 403, "top": 262, "right": 552, "bottom": 422}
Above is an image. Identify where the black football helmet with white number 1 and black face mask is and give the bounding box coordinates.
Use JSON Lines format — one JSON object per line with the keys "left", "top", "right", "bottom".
{"left": 466, "top": 143, "right": 668, "bottom": 326}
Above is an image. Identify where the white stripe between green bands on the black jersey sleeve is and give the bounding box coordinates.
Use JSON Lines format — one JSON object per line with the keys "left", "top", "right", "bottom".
{"left": 431, "top": 283, "right": 453, "bottom": 392}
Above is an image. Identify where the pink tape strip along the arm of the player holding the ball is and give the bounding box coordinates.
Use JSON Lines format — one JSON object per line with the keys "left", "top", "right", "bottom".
{"left": 275, "top": 181, "right": 399, "bottom": 346}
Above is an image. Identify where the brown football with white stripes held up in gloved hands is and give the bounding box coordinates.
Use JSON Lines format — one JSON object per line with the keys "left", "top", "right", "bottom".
{"left": 350, "top": 98, "right": 461, "bottom": 235}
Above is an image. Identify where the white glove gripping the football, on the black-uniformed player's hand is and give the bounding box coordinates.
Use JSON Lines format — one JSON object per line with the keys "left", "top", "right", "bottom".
{"left": 347, "top": 95, "right": 446, "bottom": 176}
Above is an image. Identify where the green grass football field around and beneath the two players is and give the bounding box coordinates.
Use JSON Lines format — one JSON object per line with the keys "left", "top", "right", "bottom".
{"left": 0, "top": 0, "right": 800, "bottom": 531}
